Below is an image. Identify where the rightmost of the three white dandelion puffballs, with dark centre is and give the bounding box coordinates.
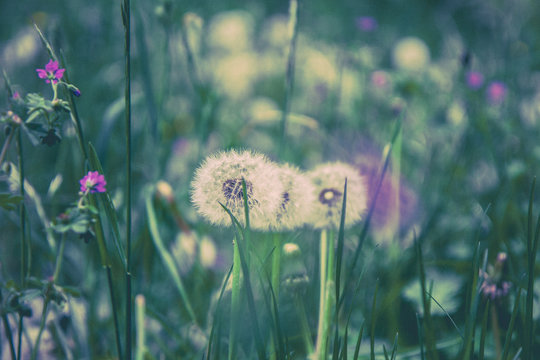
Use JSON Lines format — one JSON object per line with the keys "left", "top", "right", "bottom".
{"left": 307, "top": 162, "right": 367, "bottom": 229}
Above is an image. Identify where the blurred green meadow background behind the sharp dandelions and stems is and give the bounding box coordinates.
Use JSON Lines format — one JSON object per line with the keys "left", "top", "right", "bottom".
{"left": 0, "top": 0, "right": 540, "bottom": 359}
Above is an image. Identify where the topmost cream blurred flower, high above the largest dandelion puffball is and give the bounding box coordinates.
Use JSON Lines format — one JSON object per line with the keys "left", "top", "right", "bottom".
{"left": 207, "top": 10, "right": 255, "bottom": 52}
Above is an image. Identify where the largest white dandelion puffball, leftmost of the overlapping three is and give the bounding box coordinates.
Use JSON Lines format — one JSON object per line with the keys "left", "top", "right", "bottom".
{"left": 191, "top": 150, "right": 283, "bottom": 230}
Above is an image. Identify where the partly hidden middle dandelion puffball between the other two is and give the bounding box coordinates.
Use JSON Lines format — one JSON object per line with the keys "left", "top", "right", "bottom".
{"left": 271, "top": 164, "right": 316, "bottom": 230}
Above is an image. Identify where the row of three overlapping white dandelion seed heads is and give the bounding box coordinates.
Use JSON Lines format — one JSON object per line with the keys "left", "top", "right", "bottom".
{"left": 191, "top": 150, "right": 367, "bottom": 231}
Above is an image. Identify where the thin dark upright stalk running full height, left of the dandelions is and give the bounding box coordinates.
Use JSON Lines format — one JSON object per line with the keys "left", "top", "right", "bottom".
{"left": 122, "top": 0, "right": 133, "bottom": 360}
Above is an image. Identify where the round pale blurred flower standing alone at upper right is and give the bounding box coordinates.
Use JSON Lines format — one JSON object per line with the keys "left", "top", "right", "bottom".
{"left": 392, "top": 37, "right": 430, "bottom": 71}
